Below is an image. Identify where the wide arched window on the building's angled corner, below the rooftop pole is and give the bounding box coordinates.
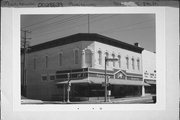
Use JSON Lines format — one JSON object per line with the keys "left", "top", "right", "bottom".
{"left": 85, "top": 49, "right": 92, "bottom": 67}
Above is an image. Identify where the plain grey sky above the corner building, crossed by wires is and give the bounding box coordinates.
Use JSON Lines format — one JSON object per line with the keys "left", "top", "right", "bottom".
{"left": 21, "top": 14, "right": 156, "bottom": 52}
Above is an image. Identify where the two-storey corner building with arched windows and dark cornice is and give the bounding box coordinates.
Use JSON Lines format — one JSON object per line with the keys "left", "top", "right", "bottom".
{"left": 21, "top": 33, "right": 155, "bottom": 100}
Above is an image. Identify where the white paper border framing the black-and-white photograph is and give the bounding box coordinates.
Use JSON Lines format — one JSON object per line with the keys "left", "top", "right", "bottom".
{"left": 2, "top": 7, "right": 179, "bottom": 119}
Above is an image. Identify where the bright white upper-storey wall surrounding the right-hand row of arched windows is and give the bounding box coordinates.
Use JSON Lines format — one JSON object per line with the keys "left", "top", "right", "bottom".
{"left": 95, "top": 42, "right": 142, "bottom": 74}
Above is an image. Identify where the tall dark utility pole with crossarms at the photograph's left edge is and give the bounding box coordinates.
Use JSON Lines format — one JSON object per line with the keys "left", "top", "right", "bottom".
{"left": 21, "top": 30, "right": 31, "bottom": 96}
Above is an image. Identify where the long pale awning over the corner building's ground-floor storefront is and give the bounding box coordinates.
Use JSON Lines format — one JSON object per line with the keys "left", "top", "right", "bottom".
{"left": 56, "top": 77, "right": 150, "bottom": 86}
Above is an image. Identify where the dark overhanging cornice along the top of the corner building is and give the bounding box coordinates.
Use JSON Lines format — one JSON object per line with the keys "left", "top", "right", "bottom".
{"left": 29, "top": 33, "right": 144, "bottom": 53}
